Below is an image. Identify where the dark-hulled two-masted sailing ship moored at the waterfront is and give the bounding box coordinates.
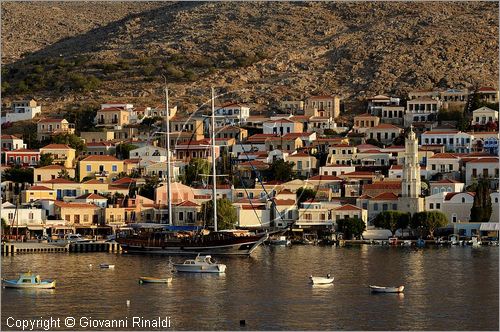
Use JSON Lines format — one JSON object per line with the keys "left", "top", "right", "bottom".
{"left": 116, "top": 88, "right": 268, "bottom": 256}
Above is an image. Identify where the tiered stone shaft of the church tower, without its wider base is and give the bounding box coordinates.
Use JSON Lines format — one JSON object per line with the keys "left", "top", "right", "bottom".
{"left": 401, "top": 126, "right": 421, "bottom": 198}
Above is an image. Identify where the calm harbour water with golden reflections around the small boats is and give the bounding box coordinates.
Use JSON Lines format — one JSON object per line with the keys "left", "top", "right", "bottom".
{"left": 1, "top": 245, "right": 499, "bottom": 330}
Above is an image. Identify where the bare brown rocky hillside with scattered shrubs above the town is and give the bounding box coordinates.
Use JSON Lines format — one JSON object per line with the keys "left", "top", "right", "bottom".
{"left": 2, "top": 2, "right": 498, "bottom": 111}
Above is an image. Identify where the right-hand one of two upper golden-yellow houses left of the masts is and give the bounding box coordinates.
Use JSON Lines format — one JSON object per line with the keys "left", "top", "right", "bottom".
{"left": 79, "top": 156, "right": 123, "bottom": 182}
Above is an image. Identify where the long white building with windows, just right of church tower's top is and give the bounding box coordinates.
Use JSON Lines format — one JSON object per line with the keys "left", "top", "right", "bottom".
{"left": 420, "top": 130, "right": 474, "bottom": 153}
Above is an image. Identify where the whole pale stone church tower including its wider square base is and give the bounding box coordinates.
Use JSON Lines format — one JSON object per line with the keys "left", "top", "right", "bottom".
{"left": 398, "top": 126, "right": 424, "bottom": 214}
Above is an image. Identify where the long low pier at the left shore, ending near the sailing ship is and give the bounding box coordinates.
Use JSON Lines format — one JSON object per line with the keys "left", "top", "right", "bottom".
{"left": 1, "top": 242, "right": 122, "bottom": 256}
